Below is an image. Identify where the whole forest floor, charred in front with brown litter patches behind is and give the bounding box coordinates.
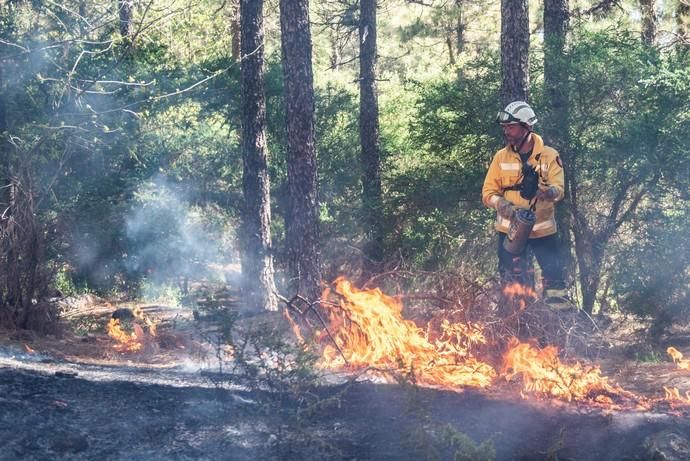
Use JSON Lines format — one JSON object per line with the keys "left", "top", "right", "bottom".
{"left": 0, "top": 290, "right": 690, "bottom": 461}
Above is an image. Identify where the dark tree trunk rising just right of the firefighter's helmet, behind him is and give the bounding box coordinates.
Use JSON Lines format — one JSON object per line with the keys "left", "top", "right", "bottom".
{"left": 543, "top": 0, "right": 574, "bottom": 288}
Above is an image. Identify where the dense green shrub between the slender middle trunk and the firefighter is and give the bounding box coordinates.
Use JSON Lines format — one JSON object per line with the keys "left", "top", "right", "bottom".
{"left": 386, "top": 55, "right": 500, "bottom": 269}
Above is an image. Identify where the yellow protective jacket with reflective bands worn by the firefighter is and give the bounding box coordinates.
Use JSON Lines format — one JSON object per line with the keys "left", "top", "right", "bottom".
{"left": 482, "top": 133, "right": 563, "bottom": 238}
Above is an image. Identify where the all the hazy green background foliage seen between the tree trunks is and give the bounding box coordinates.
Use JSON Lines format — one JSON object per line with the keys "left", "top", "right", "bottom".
{"left": 0, "top": 0, "right": 690, "bottom": 330}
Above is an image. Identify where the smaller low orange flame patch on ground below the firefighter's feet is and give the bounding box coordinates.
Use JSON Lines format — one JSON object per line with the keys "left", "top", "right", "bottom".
{"left": 502, "top": 338, "right": 615, "bottom": 403}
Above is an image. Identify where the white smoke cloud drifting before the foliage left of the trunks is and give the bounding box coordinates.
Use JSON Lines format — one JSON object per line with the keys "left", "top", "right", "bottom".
{"left": 125, "top": 176, "right": 237, "bottom": 298}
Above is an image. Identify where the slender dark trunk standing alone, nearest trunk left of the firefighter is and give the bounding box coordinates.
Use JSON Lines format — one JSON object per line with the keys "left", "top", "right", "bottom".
{"left": 359, "top": 0, "right": 383, "bottom": 270}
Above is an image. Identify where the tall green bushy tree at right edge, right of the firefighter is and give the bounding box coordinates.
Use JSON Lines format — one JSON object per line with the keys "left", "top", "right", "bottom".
{"left": 571, "top": 30, "right": 690, "bottom": 323}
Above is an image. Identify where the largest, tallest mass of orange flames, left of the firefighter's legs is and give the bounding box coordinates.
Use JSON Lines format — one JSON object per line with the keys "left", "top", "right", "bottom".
{"left": 317, "top": 278, "right": 496, "bottom": 389}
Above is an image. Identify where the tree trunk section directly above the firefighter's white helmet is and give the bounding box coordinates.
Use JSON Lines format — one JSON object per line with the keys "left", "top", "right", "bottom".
{"left": 501, "top": 0, "right": 529, "bottom": 107}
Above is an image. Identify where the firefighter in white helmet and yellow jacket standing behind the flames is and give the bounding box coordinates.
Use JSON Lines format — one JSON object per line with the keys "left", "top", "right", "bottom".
{"left": 482, "top": 101, "right": 572, "bottom": 309}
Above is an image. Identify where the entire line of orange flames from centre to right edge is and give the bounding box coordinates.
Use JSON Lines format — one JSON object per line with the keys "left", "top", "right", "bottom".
{"left": 286, "top": 277, "right": 690, "bottom": 410}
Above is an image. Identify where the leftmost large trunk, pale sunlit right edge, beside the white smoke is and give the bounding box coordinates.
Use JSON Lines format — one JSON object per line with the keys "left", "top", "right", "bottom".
{"left": 240, "top": 0, "right": 278, "bottom": 310}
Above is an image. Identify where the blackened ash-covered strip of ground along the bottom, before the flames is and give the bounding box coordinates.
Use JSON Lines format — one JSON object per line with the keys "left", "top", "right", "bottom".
{"left": 0, "top": 360, "right": 690, "bottom": 460}
